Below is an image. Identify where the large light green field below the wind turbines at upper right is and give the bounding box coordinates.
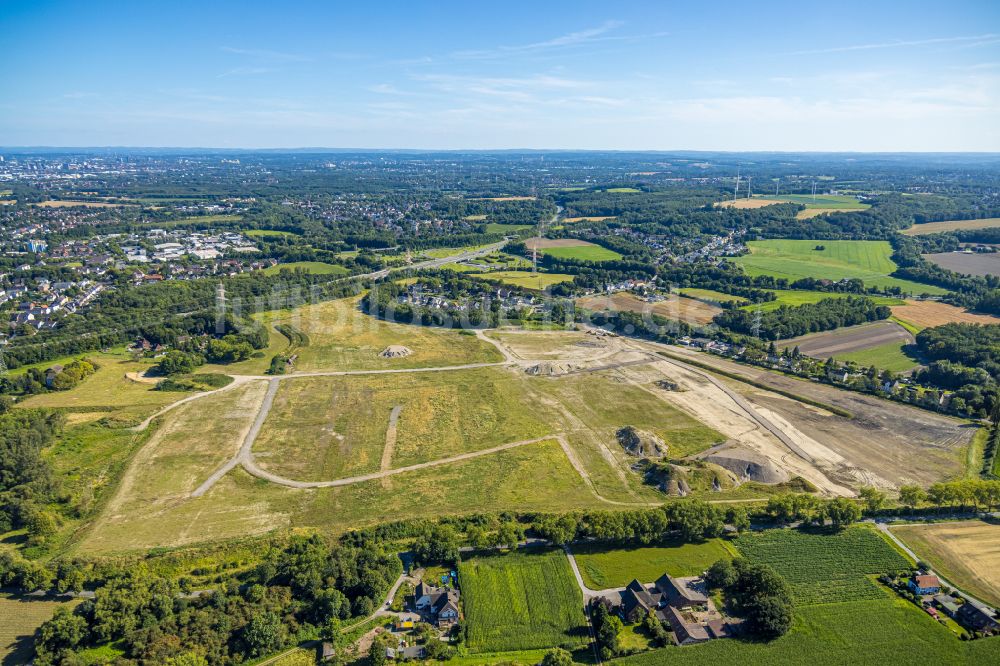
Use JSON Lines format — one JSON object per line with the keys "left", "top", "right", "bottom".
{"left": 732, "top": 240, "right": 946, "bottom": 295}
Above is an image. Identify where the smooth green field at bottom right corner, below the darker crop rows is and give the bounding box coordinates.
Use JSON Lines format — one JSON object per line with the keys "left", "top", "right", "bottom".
{"left": 611, "top": 598, "right": 1000, "bottom": 666}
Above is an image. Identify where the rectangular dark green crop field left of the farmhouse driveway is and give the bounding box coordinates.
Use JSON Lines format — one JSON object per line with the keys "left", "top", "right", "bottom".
{"left": 458, "top": 550, "right": 588, "bottom": 652}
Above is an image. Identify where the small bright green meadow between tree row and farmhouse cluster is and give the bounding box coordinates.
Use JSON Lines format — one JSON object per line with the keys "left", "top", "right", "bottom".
{"left": 573, "top": 539, "right": 733, "bottom": 590}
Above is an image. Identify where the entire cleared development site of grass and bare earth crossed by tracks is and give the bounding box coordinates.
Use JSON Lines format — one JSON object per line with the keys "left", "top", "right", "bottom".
{"left": 77, "top": 301, "right": 975, "bottom": 552}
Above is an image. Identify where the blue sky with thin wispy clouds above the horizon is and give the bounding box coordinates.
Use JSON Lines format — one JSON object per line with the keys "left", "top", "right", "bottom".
{"left": 0, "top": 0, "right": 1000, "bottom": 151}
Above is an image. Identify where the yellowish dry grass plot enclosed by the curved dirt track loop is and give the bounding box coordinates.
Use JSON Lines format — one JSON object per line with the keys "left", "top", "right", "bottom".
{"left": 254, "top": 368, "right": 552, "bottom": 481}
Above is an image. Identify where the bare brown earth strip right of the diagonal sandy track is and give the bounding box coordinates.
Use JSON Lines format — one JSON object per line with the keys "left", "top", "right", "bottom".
{"left": 645, "top": 343, "right": 978, "bottom": 486}
